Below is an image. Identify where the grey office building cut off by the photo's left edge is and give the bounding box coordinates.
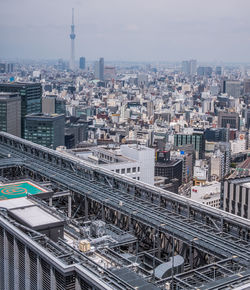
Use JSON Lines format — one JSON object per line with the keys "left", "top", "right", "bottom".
{"left": 0, "top": 93, "right": 21, "bottom": 137}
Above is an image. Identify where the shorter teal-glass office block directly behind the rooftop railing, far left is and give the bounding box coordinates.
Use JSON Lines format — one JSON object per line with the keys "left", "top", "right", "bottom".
{"left": 24, "top": 113, "right": 65, "bottom": 149}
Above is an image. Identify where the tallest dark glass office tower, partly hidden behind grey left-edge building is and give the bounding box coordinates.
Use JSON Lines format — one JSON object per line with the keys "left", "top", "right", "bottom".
{"left": 0, "top": 83, "right": 42, "bottom": 138}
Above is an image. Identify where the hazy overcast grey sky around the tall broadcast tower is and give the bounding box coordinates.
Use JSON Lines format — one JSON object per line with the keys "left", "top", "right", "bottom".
{"left": 0, "top": 0, "right": 250, "bottom": 62}
